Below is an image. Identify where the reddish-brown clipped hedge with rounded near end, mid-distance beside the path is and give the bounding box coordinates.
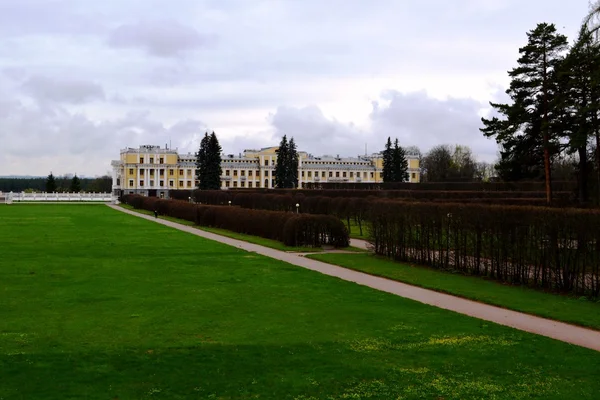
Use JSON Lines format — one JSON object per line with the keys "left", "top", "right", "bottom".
{"left": 122, "top": 195, "right": 350, "bottom": 247}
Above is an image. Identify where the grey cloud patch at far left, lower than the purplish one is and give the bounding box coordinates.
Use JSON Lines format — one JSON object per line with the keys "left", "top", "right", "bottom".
{"left": 21, "top": 76, "right": 104, "bottom": 104}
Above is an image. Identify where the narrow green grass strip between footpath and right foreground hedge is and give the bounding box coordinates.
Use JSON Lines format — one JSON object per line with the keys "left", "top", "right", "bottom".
{"left": 308, "top": 254, "right": 600, "bottom": 330}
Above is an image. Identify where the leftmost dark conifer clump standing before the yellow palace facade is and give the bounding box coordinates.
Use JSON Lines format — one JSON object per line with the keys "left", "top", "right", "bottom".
{"left": 196, "top": 132, "right": 222, "bottom": 190}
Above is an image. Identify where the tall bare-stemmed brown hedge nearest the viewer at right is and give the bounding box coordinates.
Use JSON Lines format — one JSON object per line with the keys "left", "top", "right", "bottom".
{"left": 367, "top": 200, "right": 600, "bottom": 297}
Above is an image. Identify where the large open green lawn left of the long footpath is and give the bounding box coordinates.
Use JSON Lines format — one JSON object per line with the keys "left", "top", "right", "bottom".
{"left": 0, "top": 205, "right": 600, "bottom": 400}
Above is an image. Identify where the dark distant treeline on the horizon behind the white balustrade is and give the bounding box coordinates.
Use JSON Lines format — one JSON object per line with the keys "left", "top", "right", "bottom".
{"left": 0, "top": 176, "right": 112, "bottom": 193}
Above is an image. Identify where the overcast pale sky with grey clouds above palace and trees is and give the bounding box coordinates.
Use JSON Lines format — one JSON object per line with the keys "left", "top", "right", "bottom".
{"left": 0, "top": 0, "right": 588, "bottom": 175}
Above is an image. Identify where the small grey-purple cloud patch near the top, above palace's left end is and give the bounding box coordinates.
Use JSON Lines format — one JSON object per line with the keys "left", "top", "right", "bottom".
{"left": 108, "top": 20, "right": 214, "bottom": 57}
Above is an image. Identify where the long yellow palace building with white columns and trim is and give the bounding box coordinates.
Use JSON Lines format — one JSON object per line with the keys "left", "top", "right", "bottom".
{"left": 111, "top": 145, "right": 420, "bottom": 198}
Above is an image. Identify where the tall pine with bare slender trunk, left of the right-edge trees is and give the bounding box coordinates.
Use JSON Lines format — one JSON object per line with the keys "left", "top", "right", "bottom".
{"left": 481, "top": 23, "right": 567, "bottom": 202}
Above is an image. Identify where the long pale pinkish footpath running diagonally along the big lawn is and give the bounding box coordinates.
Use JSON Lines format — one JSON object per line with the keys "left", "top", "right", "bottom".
{"left": 109, "top": 204, "right": 600, "bottom": 351}
